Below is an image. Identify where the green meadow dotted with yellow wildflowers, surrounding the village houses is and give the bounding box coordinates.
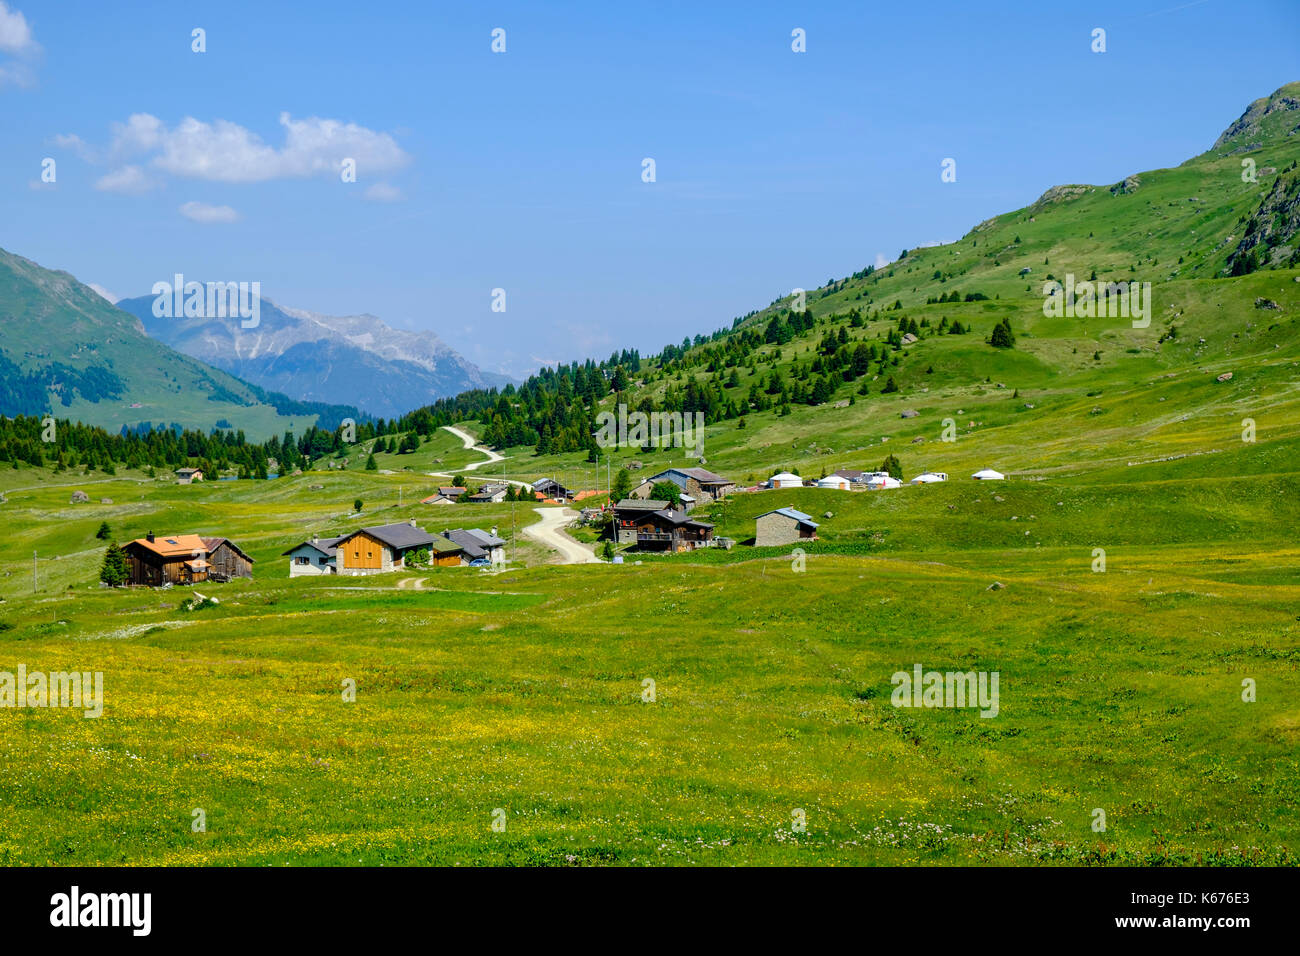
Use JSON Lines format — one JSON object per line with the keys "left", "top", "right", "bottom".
{"left": 0, "top": 429, "right": 1300, "bottom": 865}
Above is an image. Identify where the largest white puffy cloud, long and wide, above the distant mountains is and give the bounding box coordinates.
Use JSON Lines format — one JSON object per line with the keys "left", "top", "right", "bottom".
{"left": 91, "top": 113, "right": 411, "bottom": 182}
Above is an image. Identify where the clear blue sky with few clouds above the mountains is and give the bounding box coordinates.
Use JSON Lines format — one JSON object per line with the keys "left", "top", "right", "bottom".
{"left": 0, "top": 0, "right": 1300, "bottom": 375}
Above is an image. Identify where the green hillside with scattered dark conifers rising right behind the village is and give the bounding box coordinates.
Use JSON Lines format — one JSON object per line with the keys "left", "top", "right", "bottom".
{"left": 434, "top": 85, "right": 1300, "bottom": 496}
